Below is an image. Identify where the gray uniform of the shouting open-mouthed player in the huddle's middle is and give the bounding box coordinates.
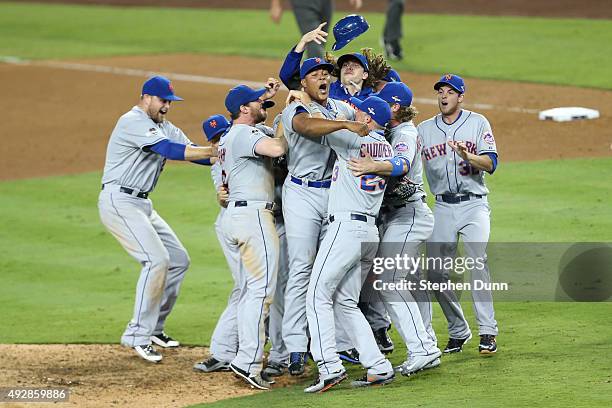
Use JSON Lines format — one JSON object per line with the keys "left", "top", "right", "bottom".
{"left": 282, "top": 99, "right": 355, "bottom": 352}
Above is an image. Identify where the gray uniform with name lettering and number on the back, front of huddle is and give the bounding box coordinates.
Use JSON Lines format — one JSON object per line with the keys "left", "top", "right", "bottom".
{"left": 306, "top": 131, "right": 393, "bottom": 378}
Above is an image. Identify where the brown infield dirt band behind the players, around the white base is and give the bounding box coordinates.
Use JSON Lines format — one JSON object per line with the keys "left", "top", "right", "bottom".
{"left": 0, "top": 55, "right": 612, "bottom": 180}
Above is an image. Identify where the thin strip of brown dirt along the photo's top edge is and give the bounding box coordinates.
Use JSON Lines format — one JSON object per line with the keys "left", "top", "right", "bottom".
{"left": 16, "top": 0, "right": 612, "bottom": 18}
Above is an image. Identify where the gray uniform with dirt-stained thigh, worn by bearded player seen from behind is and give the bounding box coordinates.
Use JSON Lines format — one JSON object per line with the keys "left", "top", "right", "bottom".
{"left": 218, "top": 125, "right": 279, "bottom": 375}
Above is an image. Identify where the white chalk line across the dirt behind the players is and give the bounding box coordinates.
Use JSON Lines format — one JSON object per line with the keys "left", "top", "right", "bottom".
{"left": 0, "top": 56, "right": 539, "bottom": 114}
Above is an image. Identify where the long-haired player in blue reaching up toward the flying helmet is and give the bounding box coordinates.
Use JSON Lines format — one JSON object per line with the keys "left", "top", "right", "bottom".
{"left": 279, "top": 23, "right": 373, "bottom": 101}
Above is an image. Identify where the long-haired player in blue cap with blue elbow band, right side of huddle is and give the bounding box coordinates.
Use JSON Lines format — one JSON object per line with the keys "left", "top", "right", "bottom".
{"left": 348, "top": 82, "right": 442, "bottom": 375}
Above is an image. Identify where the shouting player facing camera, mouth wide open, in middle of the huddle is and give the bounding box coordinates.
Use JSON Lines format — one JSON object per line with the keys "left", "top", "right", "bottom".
{"left": 282, "top": 58, "right": 366, "bottom": 375}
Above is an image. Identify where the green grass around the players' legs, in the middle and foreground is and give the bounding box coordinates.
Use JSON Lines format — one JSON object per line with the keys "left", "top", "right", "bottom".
{"left": 0, "top": 159, "right": 612, "bottom": 407}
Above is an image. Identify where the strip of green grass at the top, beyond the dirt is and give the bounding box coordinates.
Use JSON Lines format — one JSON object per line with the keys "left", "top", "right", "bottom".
{"left": 0, "top": 3, "right": 612, "bottom": 89}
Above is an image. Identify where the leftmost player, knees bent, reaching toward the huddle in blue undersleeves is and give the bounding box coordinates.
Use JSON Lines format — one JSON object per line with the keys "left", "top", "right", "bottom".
{"left": 98, "top": 76, "right": 216, "bottom": 362}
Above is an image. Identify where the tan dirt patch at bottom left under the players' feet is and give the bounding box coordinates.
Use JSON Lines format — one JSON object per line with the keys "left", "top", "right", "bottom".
{"left": 0, "top": 344, "right": 304, "bottom": 408}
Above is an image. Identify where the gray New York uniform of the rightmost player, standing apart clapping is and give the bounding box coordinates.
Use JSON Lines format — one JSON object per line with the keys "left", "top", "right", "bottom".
{"left": 418, "top": 110, "right": 497, "bottom": 339}
